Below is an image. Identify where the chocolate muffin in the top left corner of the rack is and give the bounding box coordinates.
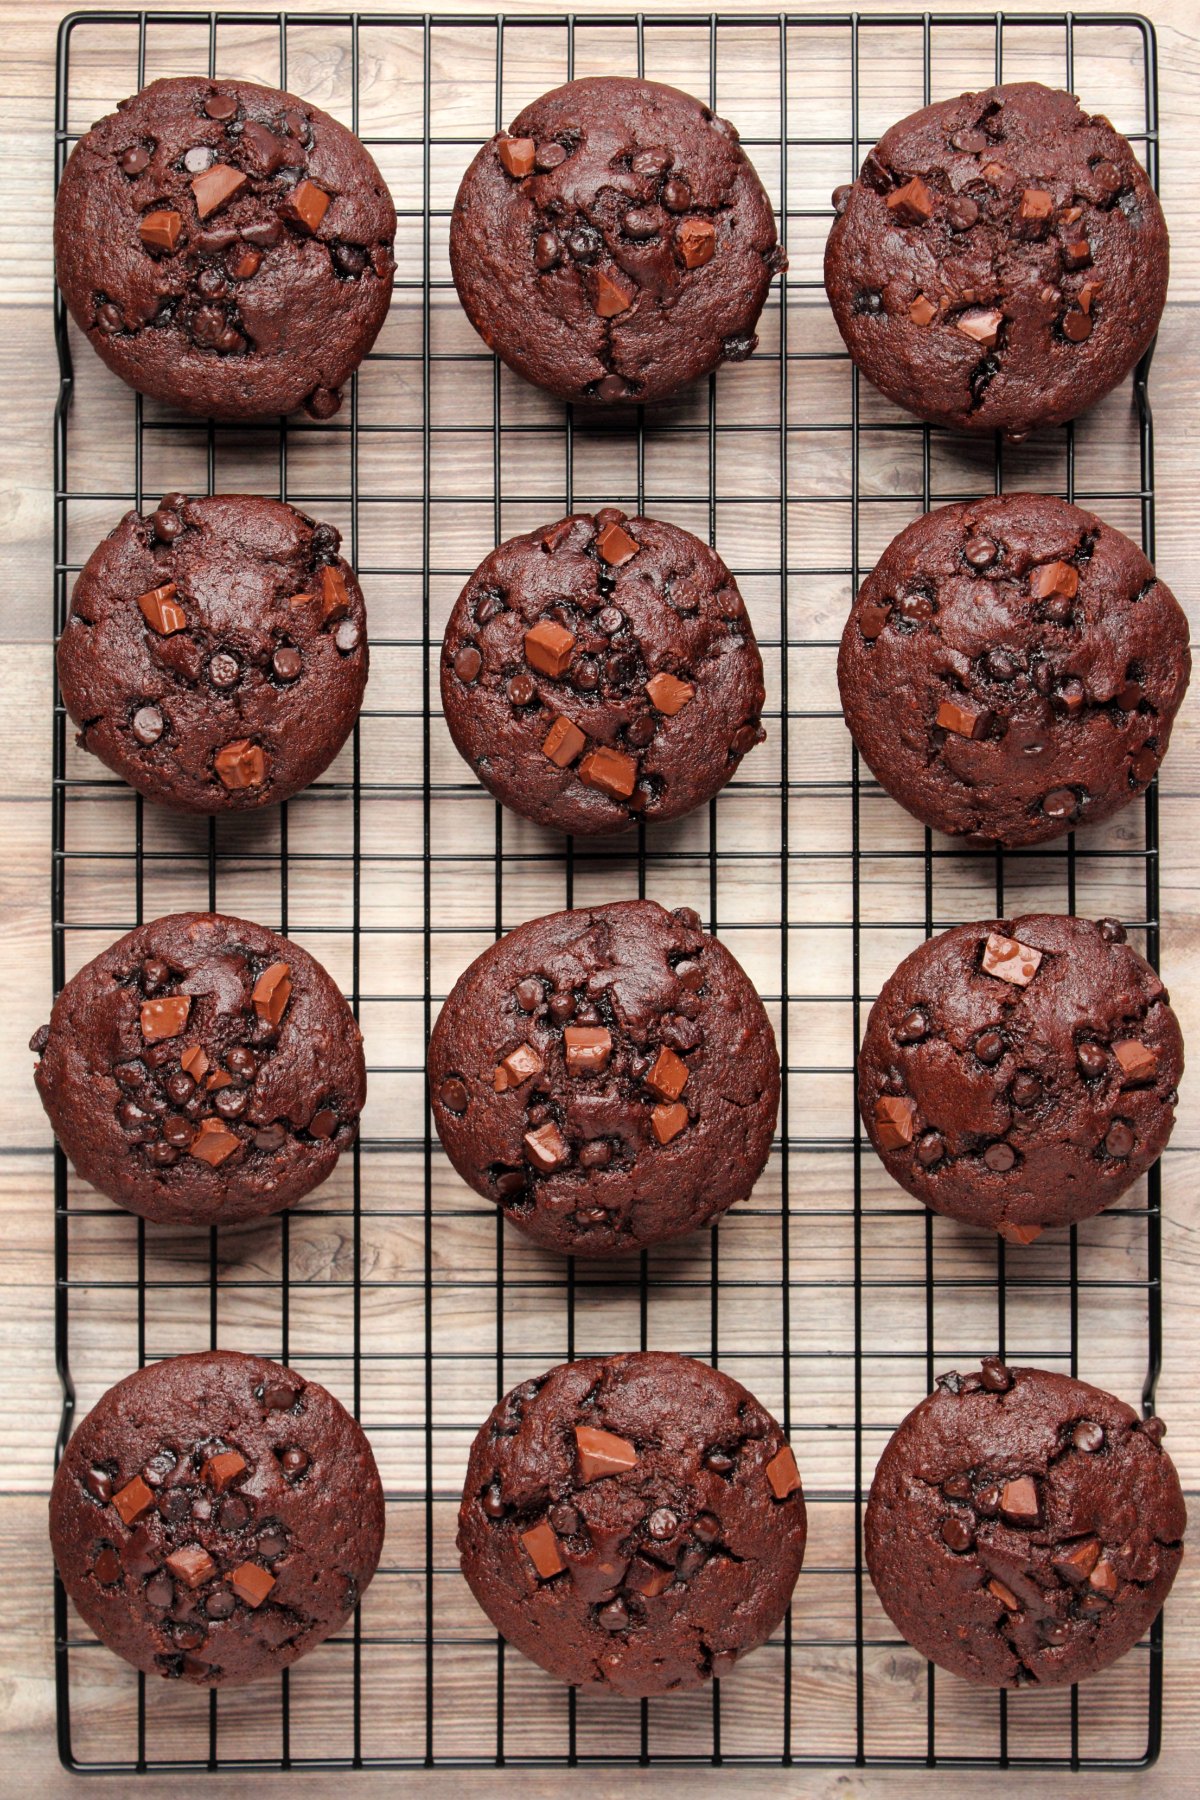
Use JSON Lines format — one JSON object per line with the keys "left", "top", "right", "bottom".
{"left": 54, "top": 76, "right": 396, "bottom": 419}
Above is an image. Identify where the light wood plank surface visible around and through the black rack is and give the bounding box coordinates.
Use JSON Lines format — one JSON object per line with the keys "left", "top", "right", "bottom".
{"left": 0, "top": 0, "right": 1200, "bottom": 1796}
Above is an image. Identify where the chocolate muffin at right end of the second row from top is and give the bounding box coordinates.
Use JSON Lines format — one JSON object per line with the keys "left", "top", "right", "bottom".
{"left": 838, "top": 493, "right": 1191, "bottom": 846}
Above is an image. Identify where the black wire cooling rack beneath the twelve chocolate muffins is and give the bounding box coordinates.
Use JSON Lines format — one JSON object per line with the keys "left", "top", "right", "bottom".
{"left": 50, "top": 0, "right": 1162, "bottom": 1771}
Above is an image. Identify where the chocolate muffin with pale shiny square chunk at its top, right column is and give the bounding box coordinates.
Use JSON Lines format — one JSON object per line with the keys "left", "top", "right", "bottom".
{"left": 858, "top": 913, "right": 1184, "bottom": 1244}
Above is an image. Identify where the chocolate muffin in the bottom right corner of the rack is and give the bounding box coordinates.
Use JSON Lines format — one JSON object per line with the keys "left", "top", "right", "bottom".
{"left": 865, "top": 1357, "right": 1187, "bottom": 1687}
